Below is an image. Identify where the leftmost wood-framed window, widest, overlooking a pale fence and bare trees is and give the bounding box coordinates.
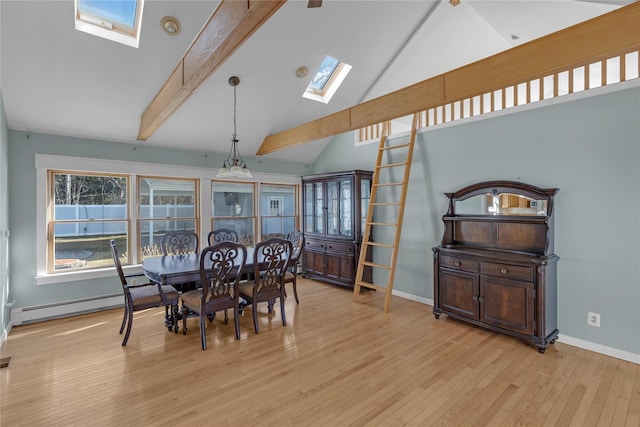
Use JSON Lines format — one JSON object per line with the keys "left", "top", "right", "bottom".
{"left": 47, "top": 171, "right": 129, "bottom": 273}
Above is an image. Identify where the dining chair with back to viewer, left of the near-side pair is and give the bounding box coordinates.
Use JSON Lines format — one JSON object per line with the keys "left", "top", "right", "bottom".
{"left": 182, "top": 242, "right": 247, "bottom": 350}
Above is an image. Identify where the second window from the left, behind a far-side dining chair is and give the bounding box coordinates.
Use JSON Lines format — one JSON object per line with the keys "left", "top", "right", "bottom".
{"left": 138, "top": 176, "right": 202, "bottom": 260}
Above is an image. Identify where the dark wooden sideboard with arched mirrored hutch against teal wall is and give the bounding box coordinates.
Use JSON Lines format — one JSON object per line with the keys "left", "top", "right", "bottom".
{"left": 433, "top": 181, "right": 559, "bottom": 353}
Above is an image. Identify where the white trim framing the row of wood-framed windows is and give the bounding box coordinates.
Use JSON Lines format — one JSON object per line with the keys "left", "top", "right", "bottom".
{"left": 35, "top": 154, "right": 300, "bottom": 285}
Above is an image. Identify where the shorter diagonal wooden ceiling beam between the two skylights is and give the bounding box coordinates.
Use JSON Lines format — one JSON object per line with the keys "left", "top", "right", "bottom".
{"left": 138, "top": 0, "right": 286, "bottom": 141}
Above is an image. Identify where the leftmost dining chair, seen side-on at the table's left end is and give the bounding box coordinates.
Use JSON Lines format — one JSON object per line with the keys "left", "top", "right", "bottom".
{"left": 109, "top": 239, "right": 178, "bottom": 346}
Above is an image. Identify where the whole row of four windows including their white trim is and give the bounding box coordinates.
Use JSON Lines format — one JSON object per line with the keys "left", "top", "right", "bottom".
{"left": 34, "top": 154, "right": 300, "bottom": 285}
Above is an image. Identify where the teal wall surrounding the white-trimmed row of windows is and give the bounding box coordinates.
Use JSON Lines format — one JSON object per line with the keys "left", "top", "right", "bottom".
{"left": 9, "top": 131, "right": 308, "bottom": 307}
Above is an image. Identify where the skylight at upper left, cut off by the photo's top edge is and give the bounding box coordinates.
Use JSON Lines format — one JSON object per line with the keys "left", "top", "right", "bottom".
{"left": 75, "top": 0, "right": 144, "bottom": 47}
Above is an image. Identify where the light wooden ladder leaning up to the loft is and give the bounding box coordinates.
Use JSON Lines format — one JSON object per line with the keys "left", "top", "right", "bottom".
{"left": 353, "top": 113, "right": 420, "bottom": 313}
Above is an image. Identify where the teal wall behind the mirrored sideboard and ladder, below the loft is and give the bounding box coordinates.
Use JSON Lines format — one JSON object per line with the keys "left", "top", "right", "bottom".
{"left": 313, "top": 85, "right": 640, "bottom": 354}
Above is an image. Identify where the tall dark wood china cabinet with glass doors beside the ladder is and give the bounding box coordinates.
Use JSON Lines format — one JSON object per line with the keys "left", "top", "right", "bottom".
{"left": 302, "top": 170, "right": 372, "bottom": 286}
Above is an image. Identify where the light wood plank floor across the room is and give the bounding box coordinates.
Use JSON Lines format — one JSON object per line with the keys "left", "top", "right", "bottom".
{"left": 0, "top": 279, "right": 640, "bottom": 426}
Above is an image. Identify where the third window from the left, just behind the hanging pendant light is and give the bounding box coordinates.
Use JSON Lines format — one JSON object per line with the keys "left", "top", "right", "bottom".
{"left": 211, "top": 181, "right": 256, "bottom": 246}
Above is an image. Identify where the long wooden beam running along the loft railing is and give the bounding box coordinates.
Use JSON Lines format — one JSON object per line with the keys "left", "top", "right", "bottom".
{"left": 257, "top": 1, "right": 640, "bottom": 155}
